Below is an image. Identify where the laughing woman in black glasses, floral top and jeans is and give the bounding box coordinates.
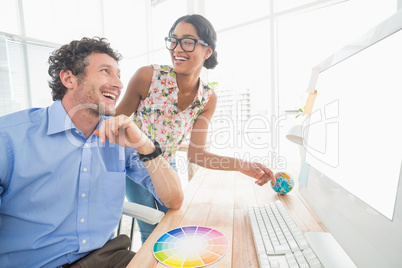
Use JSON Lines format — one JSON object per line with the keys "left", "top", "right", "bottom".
{"left": 116, "top": 15, "right": 274, "bottom": 242}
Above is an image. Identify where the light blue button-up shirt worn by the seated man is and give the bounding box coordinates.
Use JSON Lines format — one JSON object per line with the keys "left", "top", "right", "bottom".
{"left": 0, "top": 101, "right": 160, "bottom": 267}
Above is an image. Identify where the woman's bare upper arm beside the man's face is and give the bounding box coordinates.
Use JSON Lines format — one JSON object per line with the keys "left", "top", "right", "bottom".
{"left": 116, "top": 66, "right": 153, "bottom": 116}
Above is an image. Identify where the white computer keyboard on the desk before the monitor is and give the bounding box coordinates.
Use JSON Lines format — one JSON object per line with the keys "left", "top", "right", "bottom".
{"left": 248, "top": 200, "right": 323, "bottom": 268}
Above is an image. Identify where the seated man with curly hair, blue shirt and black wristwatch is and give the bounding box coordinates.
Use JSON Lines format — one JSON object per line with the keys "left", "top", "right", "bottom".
{"left": 0, "top": 38, "right": 183, "bottom": 267}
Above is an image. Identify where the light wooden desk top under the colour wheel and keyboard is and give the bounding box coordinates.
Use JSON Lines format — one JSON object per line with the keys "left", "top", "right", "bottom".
{"left": 128, "top": 168, "right": 327, "bottom": 268}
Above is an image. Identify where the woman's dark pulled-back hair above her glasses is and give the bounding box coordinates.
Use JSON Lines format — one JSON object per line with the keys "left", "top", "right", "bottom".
{"left": 169, "top": 14, "right": 218, "bottom": 69}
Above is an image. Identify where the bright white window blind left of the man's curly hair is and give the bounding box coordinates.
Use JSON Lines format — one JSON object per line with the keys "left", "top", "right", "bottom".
{"left": 0, "top": 35, "right": 56, "bottom": 116}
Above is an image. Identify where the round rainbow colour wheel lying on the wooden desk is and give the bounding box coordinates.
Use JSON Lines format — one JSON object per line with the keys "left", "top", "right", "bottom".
{"left": 153, "top": 226, "right": 229, "bottom": 267}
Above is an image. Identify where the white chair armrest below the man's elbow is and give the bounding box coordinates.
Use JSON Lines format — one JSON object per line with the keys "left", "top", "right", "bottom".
{"left": 123, "top": 202, "right": 165, "bottom": 225}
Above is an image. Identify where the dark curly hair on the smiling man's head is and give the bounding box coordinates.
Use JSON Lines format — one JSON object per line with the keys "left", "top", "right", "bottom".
{"left": 48, "top": 37, "right": 122, "bottom": 101}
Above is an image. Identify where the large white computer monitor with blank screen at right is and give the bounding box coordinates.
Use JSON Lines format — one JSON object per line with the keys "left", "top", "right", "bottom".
{"left": 299, "top": 8, "right": 402, "bottom": 268}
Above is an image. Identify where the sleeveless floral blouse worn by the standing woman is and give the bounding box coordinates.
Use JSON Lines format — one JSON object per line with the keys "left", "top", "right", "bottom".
{"left": 134, "top": 65, "right": 213, "bottom": 162}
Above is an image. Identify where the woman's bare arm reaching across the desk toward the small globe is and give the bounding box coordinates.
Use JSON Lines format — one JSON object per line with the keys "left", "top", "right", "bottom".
{"left": 188, "top": 92, "right": 275, "bottom": 185}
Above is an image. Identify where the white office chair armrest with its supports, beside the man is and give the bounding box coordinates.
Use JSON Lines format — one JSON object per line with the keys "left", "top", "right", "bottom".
{"left": 117, "top": 201, "right": 165, "bottom": 249}
